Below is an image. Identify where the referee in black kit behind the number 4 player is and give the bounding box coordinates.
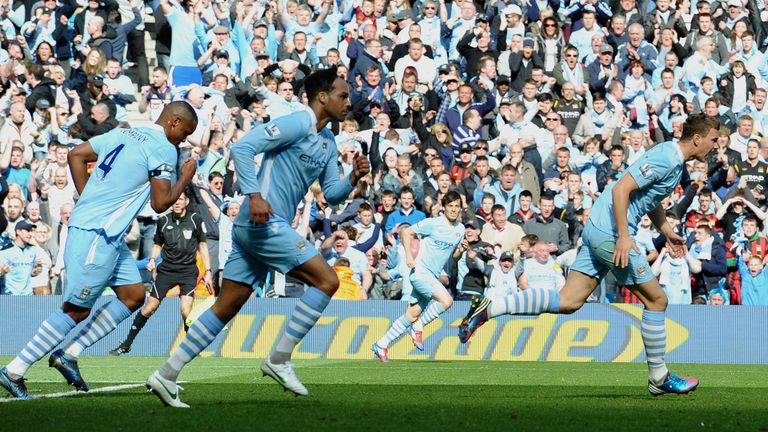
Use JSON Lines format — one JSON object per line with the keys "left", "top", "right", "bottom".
{"left": 110, "top": 193, "right": 213, "bottom": 356}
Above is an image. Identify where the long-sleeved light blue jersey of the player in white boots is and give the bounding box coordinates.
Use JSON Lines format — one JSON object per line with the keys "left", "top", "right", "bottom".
{"left": 232, "top": 109, "right": 353, "bottom": 227}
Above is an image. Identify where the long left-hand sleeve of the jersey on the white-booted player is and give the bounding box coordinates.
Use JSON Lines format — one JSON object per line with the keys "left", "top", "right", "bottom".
{"left": 231, "top": 113, "right": 310, "bottom": 195}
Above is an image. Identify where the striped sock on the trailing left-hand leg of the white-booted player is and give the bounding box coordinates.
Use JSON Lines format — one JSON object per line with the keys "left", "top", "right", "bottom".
{"left": 160, "top": 309, "right": 224, "bottom": 381}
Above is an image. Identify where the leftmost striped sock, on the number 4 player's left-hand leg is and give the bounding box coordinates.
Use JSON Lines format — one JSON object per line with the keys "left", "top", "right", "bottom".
{"left": 8, "top": 310, "right": 77, "bottom": 379}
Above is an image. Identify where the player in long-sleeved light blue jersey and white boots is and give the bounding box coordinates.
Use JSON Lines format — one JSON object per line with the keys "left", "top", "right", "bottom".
{"left": 147, "top": 67, "right": 370, "bottom": 408}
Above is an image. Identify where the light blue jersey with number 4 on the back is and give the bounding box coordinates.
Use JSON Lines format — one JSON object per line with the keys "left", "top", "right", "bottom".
{"left": 69, "top": 125, "right": 178, "bottom": 239}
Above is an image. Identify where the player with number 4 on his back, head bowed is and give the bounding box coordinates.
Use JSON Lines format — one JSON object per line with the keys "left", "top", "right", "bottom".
{"left": 0, "top": 102, "right": 197, "bottom": 399}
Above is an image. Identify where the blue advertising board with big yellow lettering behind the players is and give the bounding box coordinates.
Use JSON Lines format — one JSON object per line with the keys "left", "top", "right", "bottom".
{"left": 0, "top": 296, "right": 768, "bottom": 364}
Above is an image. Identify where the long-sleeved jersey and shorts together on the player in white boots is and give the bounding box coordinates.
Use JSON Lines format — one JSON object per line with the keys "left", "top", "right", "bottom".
{"left": 224, "top": 110, "right": 352, "bottom": 286}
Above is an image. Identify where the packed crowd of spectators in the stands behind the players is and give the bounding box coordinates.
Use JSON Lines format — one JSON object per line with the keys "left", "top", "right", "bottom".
{"left": 0, "top": 0, "right": 768, "bottom": 305}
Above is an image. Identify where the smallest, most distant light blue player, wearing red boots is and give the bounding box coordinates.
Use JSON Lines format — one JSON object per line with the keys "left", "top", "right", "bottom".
{"left": 371, "top": 191, "right": 469, "bottom": 362}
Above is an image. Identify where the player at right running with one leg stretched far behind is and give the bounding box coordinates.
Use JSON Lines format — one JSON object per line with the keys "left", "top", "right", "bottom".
{"left": 459, "top": 114, "right": 720, "bottom": 396}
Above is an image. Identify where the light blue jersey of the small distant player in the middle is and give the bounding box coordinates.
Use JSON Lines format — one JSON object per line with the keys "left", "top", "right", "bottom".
{"left": 411, "top": 216, "right": 465, "bottom": 277}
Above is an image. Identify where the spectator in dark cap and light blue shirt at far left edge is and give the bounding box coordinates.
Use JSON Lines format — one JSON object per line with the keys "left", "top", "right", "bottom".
{"left": 0, "top": 220, "right": 43, "bottom": 295}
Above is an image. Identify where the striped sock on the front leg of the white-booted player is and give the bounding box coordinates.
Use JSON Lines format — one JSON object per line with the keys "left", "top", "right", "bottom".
{"left": 270, "top": 287, "right": 331, "bottom": 364}
